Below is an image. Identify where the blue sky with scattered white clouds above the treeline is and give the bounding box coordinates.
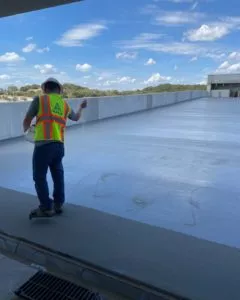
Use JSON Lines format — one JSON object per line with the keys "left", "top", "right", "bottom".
{"left": 0, "top": 0, "right": 240, "bottom": 90}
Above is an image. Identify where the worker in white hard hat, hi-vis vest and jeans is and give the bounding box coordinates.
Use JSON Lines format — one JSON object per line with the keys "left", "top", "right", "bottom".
{"left": 23, "top": 78, "right": 87, "bottom": 217}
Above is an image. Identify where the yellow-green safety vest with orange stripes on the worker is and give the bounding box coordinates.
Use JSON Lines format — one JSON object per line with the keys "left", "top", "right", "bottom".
{"left": 34, "top": 94, "right": 70, "bottom": 143}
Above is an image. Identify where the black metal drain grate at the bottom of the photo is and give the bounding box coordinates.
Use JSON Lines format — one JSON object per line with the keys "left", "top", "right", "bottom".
{"left": 15, "top": 271, "right": 102, "bottom": 300}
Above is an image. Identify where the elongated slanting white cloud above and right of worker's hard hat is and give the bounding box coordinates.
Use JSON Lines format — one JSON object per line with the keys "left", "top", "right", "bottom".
{"left": 55, "top": 23, "right": 107, "bottom": 47}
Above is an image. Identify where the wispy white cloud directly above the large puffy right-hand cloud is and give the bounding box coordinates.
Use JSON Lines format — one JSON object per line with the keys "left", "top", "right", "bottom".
{"left": 155, "top": 11, "right": 204, "bottom": 25}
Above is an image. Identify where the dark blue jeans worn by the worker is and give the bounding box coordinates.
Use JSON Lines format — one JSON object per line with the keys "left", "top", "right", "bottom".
{"left": 32, "top": 142, "right": 65, "bottom": 209}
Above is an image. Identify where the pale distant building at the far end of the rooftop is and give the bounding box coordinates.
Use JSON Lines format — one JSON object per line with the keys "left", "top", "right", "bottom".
{"left": 207, "top": 74, "right": 240, "bottom": 98}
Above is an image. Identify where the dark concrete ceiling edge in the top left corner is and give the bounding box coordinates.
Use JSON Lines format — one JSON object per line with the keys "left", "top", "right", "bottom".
{"left": 0, "top": 0, "right": 82, "bottom": 18}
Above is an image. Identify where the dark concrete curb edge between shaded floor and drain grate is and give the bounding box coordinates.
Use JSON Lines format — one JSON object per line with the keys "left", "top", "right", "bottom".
{"left": 0, "top": 232, "right": 183, "bottom": 300}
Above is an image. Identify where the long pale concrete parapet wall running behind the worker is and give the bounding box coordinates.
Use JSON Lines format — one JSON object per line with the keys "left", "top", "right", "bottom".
{"left": 0, "top": 91, "right": 209, "bottom": 140}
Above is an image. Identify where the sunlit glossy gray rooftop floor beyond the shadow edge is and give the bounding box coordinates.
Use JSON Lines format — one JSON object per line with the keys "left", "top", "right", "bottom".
{"left": 0, "top": 99, "right": 240, "bottom": 248}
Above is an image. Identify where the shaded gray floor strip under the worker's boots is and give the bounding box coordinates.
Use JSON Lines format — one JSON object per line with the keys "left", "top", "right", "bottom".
{"left": 0, "top": 189, "right": 240, "bottom": 300}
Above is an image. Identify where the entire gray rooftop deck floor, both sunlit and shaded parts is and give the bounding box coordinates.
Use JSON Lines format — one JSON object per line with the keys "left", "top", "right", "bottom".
{"left": 0, "top": 98, "right": 240, "bottom": 300}
